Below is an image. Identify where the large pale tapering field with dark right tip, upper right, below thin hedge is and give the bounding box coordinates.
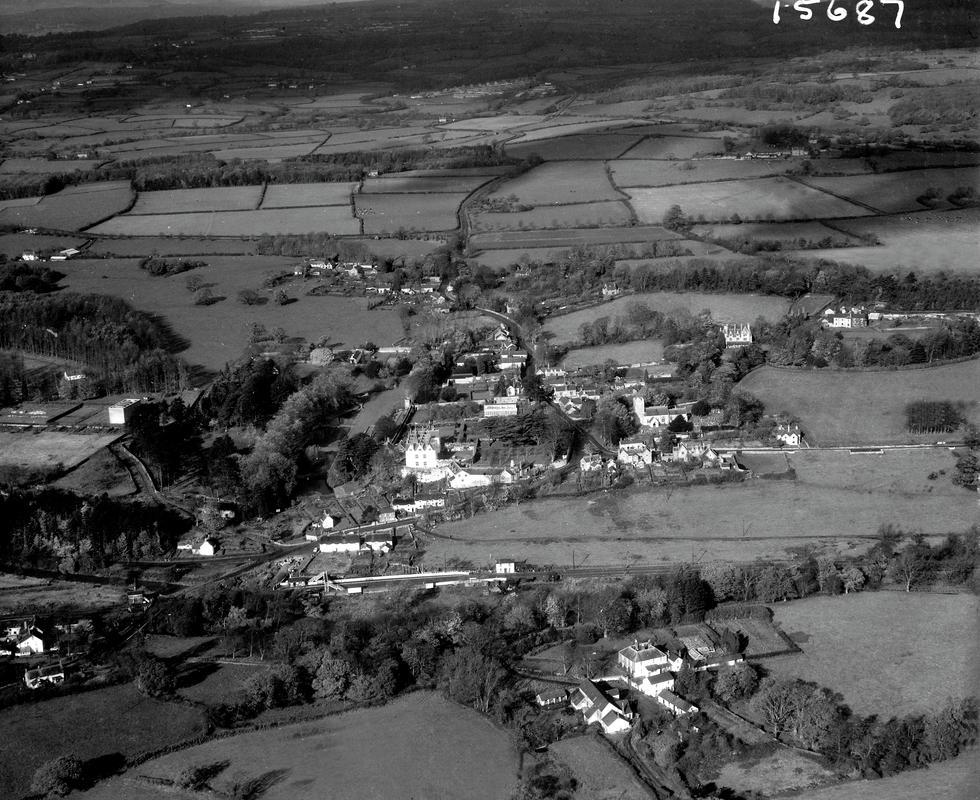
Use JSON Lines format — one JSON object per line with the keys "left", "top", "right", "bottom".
{"left": 629, "top": 178, "right": 871, "bottom": 224}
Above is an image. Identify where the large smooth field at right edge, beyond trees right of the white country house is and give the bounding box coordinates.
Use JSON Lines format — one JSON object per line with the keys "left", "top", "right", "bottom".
{"left": 765, "top": 592, "right": 980, "bottom": 718}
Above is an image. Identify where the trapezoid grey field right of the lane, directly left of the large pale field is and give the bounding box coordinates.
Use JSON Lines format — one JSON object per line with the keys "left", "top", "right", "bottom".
{"left": 491, "top": 161, "right": 624, "bottom": 206}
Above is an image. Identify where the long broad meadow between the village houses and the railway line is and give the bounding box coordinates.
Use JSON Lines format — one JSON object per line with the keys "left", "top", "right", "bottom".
{"left": 425, "top": 448, "right": 976, "bottom": 566}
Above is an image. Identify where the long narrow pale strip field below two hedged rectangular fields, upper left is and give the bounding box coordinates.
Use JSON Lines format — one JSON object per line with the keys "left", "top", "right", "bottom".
{"left": 92, "top": 205, "right": 361, "bottom": 237}
